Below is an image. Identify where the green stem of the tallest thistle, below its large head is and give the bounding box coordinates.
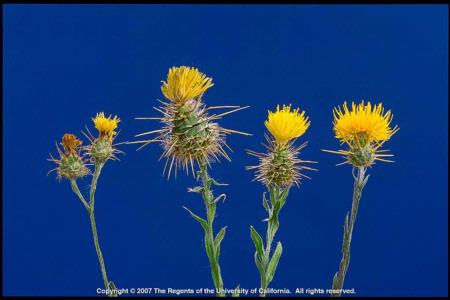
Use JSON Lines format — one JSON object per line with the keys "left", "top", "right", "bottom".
{"left": 200, "top": 163, "right": 225, "bottom": 297}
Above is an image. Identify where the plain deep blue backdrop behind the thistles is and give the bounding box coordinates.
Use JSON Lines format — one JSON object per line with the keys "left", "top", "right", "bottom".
{"left": 2, "top": 5, "right": 448, "bottom": 296}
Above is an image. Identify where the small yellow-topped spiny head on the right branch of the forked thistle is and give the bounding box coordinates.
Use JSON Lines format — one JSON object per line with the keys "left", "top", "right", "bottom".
{"left": 86, "top": 112, "right": 123, "bottom": 163}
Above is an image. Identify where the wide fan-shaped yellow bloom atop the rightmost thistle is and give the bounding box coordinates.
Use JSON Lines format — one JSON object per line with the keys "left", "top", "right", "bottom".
{"left": 333, "top": 101, "right": 397, "bottom": 146}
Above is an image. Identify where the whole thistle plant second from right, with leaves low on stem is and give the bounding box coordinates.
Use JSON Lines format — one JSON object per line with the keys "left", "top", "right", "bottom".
{"left": 246, "top": 105, "right": 315, "bottom": 297}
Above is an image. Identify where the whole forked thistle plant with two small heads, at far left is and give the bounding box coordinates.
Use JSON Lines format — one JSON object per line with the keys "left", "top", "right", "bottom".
{"left": 49, "top": 113, "right": 123, "bottom": 297}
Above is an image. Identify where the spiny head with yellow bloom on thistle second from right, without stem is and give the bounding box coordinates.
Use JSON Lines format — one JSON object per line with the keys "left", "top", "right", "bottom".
{"left": 246, "top": 105, "right": 315, "bottom": 187}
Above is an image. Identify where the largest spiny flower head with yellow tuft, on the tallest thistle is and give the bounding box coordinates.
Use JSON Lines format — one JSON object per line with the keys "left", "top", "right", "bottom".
{"left": 131, "top": 66, "right": 250, "bottom": 177}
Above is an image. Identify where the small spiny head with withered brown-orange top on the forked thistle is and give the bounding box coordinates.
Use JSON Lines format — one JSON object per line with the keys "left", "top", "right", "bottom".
{"left": 49, "top": 133, "right": 90, "bottom": 180}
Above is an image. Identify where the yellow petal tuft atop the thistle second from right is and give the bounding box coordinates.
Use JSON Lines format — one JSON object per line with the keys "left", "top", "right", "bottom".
{"left": 264, "top": 105, "right": 311, "bottom": 145}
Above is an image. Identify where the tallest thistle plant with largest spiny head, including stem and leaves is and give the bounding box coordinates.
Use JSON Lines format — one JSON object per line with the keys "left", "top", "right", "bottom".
{"left": 130, "top": 66, "right": 248, "bottom": 296}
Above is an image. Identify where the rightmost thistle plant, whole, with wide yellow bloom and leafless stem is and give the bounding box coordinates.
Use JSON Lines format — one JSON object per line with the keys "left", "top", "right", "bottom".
{"left": 324, "top": 101, "right": 399, "bottom": 296}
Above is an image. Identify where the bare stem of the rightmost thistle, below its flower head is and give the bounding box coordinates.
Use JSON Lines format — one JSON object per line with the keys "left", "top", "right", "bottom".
{"left": 332, "top": 167, "right": 367, "bottom": 297}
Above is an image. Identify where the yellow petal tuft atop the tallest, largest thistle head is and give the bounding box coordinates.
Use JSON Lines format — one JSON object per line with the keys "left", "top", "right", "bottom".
{"left": 161, "top": 66, "right": 213, "bottom": 104}
